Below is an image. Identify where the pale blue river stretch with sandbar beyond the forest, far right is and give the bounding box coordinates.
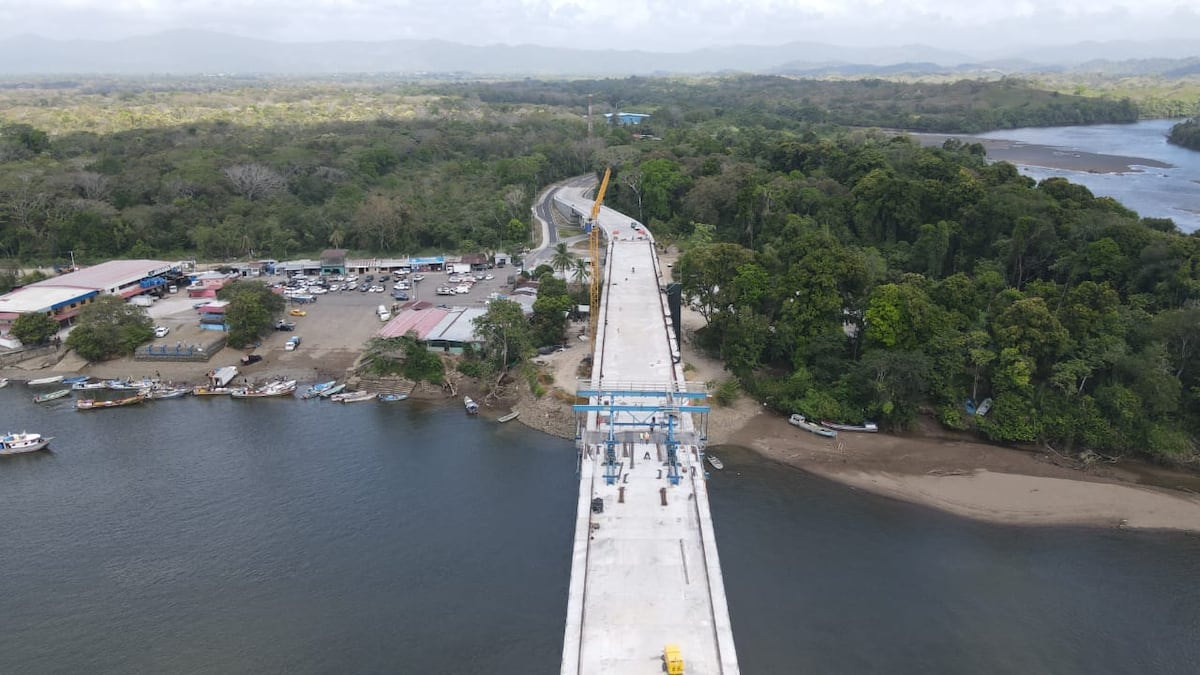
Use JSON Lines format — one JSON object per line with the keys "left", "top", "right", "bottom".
{"left": 979, "top": 120, "right": 1200, "bottom": 232}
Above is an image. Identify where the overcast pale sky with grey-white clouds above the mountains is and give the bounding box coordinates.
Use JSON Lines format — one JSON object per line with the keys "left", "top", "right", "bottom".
{"left": 0, "top": 0, "right": 1200, "bottom": 53}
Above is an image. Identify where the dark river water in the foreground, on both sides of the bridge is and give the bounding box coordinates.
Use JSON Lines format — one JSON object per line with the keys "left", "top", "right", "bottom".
{"left": 7, "top": 384, "right": 1200, "bottom": 675}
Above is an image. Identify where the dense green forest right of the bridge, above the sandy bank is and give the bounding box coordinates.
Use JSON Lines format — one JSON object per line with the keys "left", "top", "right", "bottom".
{"left": 595, "top": 130, "right": 1200, "bottom": 460}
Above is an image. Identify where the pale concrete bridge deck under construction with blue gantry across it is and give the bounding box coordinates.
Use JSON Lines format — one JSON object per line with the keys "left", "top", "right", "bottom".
{"left": 556, "top": 187, "right": 738, "bottom": 675}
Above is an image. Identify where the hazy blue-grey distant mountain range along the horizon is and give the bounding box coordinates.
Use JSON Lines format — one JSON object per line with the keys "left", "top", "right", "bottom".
{"left": 0, "top": 30, "right": 1200, "bottom": 77}
